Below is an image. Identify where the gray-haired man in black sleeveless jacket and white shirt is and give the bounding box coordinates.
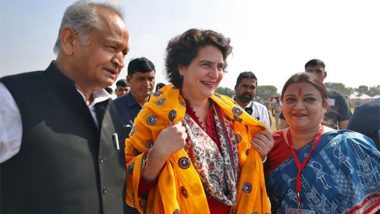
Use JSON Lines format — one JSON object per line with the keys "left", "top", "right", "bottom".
{"left": 0, "top": 1, "right": 128, "bottom": 214}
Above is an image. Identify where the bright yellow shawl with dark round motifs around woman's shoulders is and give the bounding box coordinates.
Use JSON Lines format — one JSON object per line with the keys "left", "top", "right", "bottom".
{"left": 125, "top": 84, "right": 270, "bottom": 214}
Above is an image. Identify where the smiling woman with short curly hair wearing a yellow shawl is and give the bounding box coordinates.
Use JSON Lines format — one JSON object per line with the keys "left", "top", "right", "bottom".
{"left": 125, "top": 29, "right": 273, "bottom": 213}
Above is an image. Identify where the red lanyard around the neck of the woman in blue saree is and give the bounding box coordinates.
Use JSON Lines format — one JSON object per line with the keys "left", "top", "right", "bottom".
{"left": 286, "top": 126, "right": 323, "bottom": 208}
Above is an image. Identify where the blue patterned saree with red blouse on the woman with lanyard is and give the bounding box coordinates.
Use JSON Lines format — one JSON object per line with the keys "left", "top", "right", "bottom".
{"left": 265, "top": 130, "right": 380, "bottom": 214}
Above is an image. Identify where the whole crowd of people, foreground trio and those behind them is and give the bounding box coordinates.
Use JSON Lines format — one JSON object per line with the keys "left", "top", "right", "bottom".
{"left": 0, "top": 1, "right": 380, "bottom": 214}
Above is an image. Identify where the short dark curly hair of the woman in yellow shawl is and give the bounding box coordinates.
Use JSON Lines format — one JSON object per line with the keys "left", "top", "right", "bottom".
{"left": 165, "top": 29, "right": 232, "bottom": 88}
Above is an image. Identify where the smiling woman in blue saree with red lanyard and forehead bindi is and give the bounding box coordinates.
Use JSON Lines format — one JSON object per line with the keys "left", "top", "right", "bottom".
{"left": 265, "top": 73, "right": 380, "bottom": 213}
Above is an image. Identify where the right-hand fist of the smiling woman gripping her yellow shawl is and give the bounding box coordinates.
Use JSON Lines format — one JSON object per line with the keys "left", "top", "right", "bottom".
{"left": 251, "top": 130, "right": 274, "bottom": 160}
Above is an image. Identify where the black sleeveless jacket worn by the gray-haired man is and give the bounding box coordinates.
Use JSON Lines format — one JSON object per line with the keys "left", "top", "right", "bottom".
{"left": 0, "top": 62, "right": 126, "bottom": 214}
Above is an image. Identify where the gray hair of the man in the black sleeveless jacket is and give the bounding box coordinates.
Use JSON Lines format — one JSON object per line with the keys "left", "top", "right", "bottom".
{"left": 53, "top": 0, "right": 123, "bottom": 54}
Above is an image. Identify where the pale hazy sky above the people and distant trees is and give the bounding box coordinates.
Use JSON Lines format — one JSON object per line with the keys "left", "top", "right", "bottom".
{"left": 0, "top": 0, "right": 380, "bottom": 92}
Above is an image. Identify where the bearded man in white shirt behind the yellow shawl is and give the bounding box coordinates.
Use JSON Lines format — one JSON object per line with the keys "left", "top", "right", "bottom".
{"left": 234, "top": 71, "right": 271, "bottom": 130}
